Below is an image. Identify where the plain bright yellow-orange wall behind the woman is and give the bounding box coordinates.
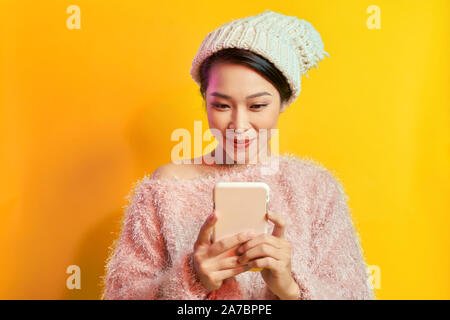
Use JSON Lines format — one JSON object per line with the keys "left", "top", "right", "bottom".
{"left": 0, "top": 0, "right": 450, "bottom": 299}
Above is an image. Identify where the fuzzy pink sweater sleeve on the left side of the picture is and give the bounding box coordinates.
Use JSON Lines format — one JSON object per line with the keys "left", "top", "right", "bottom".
{"left": 101, "top": 177, "right": 208, "bottom": 300}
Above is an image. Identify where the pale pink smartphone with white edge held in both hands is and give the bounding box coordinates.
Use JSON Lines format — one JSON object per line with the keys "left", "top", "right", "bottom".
{"left": 212, "top": 182, "right": 270, "bottom": 271}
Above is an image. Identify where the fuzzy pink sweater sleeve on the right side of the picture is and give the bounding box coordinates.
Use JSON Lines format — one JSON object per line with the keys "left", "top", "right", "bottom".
{"left": 292, "top": 172, "right": 374, "bottom": 300}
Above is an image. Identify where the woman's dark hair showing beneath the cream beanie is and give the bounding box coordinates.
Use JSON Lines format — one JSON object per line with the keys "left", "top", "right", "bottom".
{"left": 199, "top": 48, "right": 292, "bottom": 103}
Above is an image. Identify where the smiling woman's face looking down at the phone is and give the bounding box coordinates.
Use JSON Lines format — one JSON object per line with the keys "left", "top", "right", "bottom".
{"left": 205, "top": 62, "right": 285, "bottom": 163}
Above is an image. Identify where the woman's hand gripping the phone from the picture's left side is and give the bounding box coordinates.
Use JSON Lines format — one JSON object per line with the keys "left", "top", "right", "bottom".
{"left": 194, "top": 212, "right": 255, "bottom": 291}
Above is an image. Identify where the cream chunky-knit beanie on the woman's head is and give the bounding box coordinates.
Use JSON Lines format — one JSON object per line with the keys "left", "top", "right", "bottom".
{"left": 191, "top": 9, "right": 330, "bottom": 105}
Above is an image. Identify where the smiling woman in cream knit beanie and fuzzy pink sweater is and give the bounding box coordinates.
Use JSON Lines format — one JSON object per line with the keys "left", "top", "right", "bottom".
{"left": 102, "top": 10, "right": 374, "bottom": 299}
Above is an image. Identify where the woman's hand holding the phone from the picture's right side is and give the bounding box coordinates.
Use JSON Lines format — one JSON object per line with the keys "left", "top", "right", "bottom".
{"left": 238, "top": 211, "right": 299, "bottom": 300}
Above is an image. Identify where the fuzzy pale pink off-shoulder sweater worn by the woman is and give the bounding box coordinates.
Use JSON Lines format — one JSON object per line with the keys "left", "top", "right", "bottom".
{"left": 101, "top": 154, "right": 375, "bottom": 300}
